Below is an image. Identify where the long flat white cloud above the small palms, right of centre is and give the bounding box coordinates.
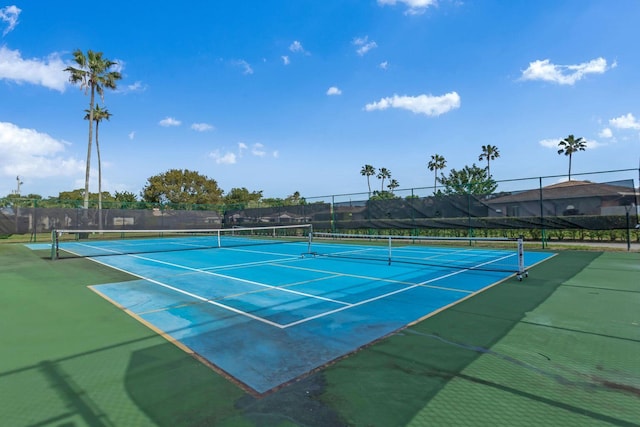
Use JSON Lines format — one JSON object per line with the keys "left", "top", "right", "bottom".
{"left": 365, "top": 92, "right": 460, "bottom": 117}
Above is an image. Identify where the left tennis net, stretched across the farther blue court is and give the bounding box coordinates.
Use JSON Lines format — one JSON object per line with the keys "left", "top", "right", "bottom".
{"left": 51, "top": 224, "right": 311, "bottom": 260}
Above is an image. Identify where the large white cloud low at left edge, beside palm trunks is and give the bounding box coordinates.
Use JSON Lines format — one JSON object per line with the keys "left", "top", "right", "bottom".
{"left": 0, "top": 122, "right": 84, "bottom": 178}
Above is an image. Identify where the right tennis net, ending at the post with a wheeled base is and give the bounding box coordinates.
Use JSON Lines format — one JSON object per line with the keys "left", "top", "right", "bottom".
{"left": 309, "top": 232, "right": 528, "bottom": 280}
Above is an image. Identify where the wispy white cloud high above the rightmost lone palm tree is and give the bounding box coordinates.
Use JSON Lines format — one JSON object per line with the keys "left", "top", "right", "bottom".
{"left": 521, "top": 58, "right": 616, "bottom": 85}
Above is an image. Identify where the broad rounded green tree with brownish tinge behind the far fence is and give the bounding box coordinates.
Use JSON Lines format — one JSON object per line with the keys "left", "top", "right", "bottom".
{"left": 141, "top": 169, "right": 223, "bottom": 204}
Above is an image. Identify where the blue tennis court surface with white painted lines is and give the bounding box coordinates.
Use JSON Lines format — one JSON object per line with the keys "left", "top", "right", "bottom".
{"left": 63, "top": 237, "right": 553, "bottom": 393}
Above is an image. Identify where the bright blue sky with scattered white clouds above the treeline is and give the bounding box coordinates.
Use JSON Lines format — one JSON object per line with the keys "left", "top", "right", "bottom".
{"left": 0, "top": 0, "right": 640, "bottom": 198}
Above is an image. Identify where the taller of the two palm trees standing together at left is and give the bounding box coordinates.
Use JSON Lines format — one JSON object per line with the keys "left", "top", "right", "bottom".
{"left": 64, "top": 49, "right": 122, "bottom": 209}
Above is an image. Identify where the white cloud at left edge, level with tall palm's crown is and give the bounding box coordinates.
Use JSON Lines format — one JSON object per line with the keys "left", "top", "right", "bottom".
{"left": 0, "top": 46, "right": 69, "bottom": 92}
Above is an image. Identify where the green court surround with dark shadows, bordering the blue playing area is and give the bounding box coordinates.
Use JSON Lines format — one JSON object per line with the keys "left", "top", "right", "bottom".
{"left": 0, "top": 245, "right": 640, "bottom": 426}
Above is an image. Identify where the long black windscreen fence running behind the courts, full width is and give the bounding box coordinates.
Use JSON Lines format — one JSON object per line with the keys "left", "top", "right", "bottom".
{"left": 0, "top": 178, "right": 638, "bottom": 239}
